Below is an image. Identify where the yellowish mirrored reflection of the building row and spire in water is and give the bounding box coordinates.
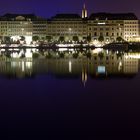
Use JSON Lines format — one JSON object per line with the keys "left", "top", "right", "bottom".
{"left": 0, "top": 50, "right": 139, "bottom": 86}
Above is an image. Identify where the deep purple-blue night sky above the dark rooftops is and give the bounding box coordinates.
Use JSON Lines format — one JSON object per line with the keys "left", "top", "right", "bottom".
{"left": 0, "top": 0, "right": 140, "bottom": 18}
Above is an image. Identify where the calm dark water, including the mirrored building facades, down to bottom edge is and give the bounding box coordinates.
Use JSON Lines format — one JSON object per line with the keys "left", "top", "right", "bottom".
{"left": 0, "top": 49, "right": 140, "bottom": 140}
